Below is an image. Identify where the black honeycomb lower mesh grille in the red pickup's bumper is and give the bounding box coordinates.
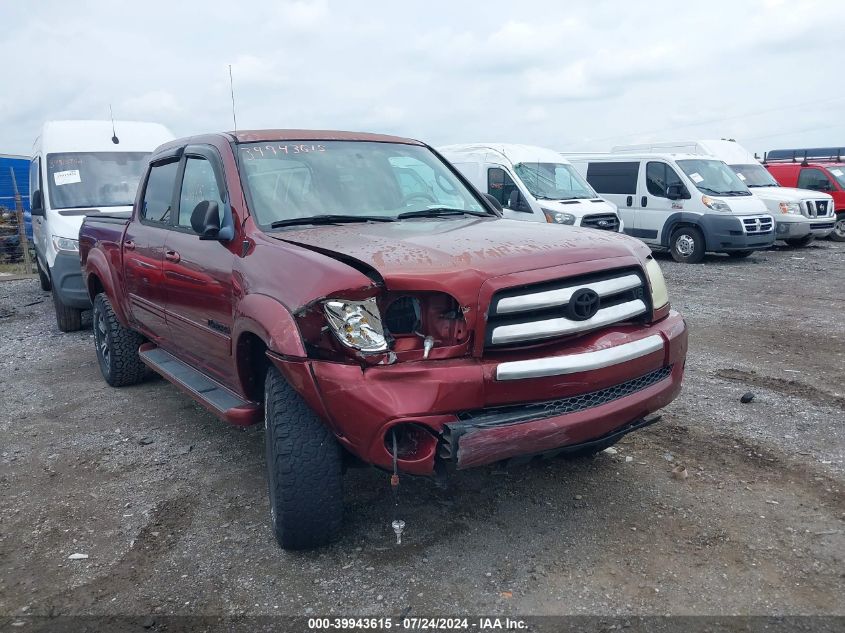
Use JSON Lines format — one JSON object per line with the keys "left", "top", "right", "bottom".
{"left": 458, "top": 365, "right": 673, "bottom": 427}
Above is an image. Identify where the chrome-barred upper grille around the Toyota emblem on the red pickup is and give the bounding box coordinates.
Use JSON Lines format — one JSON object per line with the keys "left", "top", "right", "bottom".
{"left": 485, "top": 268, "right": 651, "bottom": 348}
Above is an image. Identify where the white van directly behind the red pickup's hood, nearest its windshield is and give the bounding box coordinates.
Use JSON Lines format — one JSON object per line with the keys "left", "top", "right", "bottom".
{"left": 438, "top": 143, "right": 622, "bottom": 232}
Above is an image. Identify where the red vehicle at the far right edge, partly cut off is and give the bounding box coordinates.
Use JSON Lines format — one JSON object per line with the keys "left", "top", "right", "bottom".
{"left": 763, "top": 147, "right": 845, "bottom": 242}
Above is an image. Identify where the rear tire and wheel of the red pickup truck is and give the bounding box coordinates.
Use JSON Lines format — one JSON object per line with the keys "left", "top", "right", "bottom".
{"left": 92, "top": 292, "right": 147, "bottom": 387}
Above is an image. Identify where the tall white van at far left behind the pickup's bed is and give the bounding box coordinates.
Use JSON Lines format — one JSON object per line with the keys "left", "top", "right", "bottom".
{"left": 29, "top": 121, "right": 173, "bottom": 332}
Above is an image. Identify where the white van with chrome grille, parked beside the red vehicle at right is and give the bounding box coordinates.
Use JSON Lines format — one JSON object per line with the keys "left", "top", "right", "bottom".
{"left": 612, "top": 140, "right": 836, "bottom": 246}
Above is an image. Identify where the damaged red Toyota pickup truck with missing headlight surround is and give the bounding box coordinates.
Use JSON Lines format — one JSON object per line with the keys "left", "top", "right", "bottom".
{"left": 79, "top": 130, "right": 687, "bottom": 548}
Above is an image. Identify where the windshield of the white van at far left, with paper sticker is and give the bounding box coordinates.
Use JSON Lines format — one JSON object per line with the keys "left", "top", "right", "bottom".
{"left": 47, "top": 152, "right": 149, "bottom": 209}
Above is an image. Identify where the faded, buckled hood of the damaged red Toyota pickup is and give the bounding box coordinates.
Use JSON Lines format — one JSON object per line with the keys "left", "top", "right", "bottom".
{"left": 269, "top": 215, "right": 648, "bottom": 294}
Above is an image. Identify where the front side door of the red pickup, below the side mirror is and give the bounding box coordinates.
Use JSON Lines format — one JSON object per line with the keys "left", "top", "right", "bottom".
{"left": 163, "top": 146, "right": 234, "bottom": 386}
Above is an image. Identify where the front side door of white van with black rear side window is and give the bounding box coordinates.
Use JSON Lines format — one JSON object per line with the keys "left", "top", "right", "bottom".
{"left": 636, "top": 160, "right": 691, "bottom": 245}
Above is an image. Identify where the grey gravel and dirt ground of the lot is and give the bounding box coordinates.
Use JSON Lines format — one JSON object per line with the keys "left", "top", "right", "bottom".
{"left": 0, "top": 241, "right": 845, "bottom": 618}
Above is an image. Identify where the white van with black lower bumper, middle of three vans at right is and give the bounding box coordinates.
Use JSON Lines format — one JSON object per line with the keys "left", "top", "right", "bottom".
{"left": 569, "top": 153, "right": 775, "bottom": 263}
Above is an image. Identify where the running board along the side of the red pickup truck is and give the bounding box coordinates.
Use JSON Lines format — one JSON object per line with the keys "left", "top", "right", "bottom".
{"left": 138, "top": 343, "right": 262, "bottom": 426}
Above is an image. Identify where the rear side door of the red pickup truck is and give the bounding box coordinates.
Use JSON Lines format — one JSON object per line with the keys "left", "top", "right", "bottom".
{"left": 122, "top": 156, "right": 179, "bottom": 342}
